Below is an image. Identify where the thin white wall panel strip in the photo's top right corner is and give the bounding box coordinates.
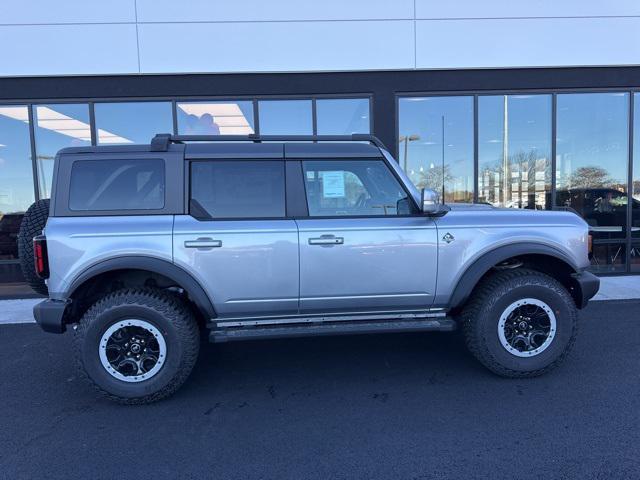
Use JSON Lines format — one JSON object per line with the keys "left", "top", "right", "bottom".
{"left": 416, "top": 0, "right": 640, "bottom": 19}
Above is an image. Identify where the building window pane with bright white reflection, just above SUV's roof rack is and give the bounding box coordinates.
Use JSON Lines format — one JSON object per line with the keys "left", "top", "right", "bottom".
{"left": 176, "top": 101, "right": 255, "bottom": 135}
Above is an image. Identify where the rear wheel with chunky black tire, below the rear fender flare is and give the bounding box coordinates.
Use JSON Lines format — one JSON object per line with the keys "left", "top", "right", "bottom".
{"left": 75, "top": 289, "right": 200, "bottom": 404}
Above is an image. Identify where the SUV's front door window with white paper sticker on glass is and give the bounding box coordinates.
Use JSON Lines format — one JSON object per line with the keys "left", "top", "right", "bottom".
{"left": 303, "top": 160, "right": 415, "bottom": 217}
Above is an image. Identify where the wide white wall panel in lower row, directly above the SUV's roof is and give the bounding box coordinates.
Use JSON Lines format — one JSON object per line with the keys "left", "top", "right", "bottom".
{"left": 139, "top": 20, "right": 414, "bottom": 73}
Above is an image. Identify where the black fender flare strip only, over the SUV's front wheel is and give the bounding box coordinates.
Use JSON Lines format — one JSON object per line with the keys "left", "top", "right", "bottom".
{"left": 449, "top": 242, "right": 580, "bottom": 309}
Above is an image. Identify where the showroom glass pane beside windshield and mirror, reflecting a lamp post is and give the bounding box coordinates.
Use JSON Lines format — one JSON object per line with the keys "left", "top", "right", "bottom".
{"left": 398, "top": 96, "right": 473, "bottom": 202}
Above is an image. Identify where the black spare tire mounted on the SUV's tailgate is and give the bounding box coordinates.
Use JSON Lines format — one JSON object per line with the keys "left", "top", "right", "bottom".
{"left": 18, "top": 198, "right": 49, "bottom": 296}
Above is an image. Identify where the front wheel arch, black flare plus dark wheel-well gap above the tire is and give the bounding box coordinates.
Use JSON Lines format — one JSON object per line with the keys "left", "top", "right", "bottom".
{"left": 449, "top": 242, "right": 583, "bottom": 310}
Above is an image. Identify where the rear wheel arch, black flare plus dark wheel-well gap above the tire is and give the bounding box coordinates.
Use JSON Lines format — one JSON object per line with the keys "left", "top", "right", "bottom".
{"left": 63, "top": 256, "right": 216, "bottom": 320}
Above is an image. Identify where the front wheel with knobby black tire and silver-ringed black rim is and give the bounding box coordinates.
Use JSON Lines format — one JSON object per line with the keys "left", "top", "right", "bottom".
{"left": 461, "top": 269, "right": 577, "bottom": 378}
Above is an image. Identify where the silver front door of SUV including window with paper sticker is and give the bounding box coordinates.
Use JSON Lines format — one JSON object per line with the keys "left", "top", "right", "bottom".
{"left": 297, "top": 158, "right": 437, "bottom": 313}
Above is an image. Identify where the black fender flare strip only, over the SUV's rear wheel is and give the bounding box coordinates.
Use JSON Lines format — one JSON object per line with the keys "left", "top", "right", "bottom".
{"left": 64, "top": 255, "right": 216, "bottom": 319}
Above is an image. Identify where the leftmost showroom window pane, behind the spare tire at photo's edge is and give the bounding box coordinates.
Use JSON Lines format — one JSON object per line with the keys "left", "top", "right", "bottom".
{"left": 0, "top": 105, "right": 34, "bottom": 263}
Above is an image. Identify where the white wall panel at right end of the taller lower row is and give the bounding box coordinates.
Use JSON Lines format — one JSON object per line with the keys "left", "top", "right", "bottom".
{"left": 416, "top": 18, "right": 640, "bottom": 68}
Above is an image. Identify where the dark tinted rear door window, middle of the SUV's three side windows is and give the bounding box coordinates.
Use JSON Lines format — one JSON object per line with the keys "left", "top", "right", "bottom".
{"left": 190, "top": 160, "right": 285, "bottom": 219}
